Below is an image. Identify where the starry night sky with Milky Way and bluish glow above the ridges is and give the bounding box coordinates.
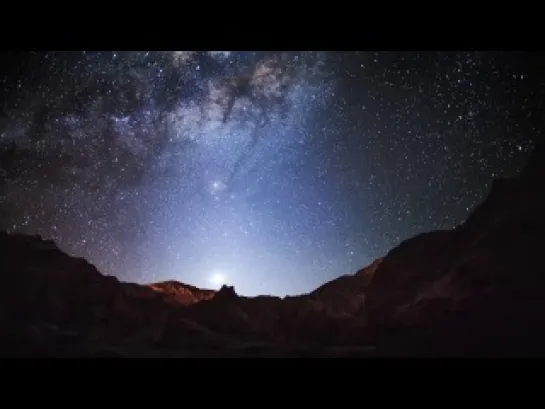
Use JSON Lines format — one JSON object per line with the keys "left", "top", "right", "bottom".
{"left": 0, "top": 51, "right": 545, "bottom": 296}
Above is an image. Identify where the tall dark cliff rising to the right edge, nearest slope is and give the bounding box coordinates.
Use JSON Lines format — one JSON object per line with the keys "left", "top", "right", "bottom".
{"left": 366, "top": 140, "right": 545, "bottom": 355}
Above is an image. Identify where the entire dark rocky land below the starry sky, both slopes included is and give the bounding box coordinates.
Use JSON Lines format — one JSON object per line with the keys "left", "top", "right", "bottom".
{"left": 0, "top": 145, "right": 545, "bottom": 357}
